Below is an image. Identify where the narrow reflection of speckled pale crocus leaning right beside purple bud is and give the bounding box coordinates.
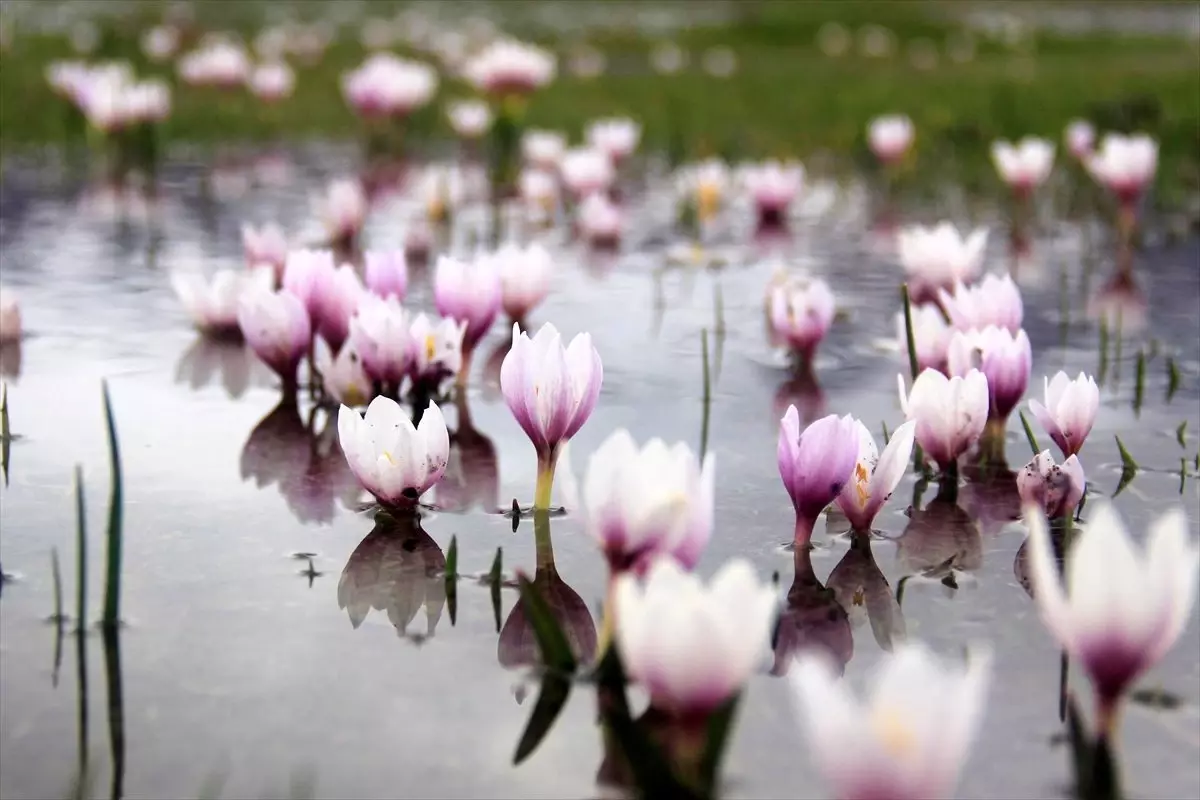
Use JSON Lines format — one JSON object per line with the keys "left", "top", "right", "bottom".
{"left": 826, "top": 531, "right": 905, "bottom": 652}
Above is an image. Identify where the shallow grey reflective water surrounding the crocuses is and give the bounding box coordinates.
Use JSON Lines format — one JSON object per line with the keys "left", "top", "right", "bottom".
{"left": 0, "top": 145, "right": 1200, "bottom": 798}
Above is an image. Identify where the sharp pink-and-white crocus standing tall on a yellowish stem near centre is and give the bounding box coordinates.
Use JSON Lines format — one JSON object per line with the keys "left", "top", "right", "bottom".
{"left": 500, "top": 323, "right": 604, "bottom": 509}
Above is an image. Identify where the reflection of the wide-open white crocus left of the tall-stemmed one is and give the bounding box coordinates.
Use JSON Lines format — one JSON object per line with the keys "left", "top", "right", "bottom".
{"left": 337, "top": 512, "right": 446, "bottom": 644}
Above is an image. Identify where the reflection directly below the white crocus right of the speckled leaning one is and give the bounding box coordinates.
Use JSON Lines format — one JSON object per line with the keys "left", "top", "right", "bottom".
{"left": 896, "top": 485, "right": 983, "bottom": 588}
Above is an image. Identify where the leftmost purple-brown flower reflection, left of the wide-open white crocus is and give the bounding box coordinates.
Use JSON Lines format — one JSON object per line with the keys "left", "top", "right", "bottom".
{"left": 241, "top": 396, "right": 359, "bottom": 523}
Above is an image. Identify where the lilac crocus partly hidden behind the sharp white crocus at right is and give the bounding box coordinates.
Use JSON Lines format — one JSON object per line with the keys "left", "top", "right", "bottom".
{"left": 947, "top": 325, "right": 1033, "bottom": 420}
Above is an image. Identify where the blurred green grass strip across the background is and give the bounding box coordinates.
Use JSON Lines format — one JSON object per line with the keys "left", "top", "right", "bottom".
{"left": 0, "top": 0, "right": 1200, "bottom": 194}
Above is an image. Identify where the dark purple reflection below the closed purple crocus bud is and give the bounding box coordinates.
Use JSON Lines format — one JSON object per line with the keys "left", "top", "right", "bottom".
{"left": 770, "top": 545, "right": 854, "bottom": 675}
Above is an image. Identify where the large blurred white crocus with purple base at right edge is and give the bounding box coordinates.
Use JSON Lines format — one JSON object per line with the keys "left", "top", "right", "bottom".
{"left": 1025, "top": 503, "right": 1200, "bottom": 735}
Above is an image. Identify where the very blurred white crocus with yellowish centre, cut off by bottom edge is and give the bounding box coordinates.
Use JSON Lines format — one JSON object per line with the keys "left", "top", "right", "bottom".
{"left": 790, "top": 643, "right": 991, "bottom": 800}
